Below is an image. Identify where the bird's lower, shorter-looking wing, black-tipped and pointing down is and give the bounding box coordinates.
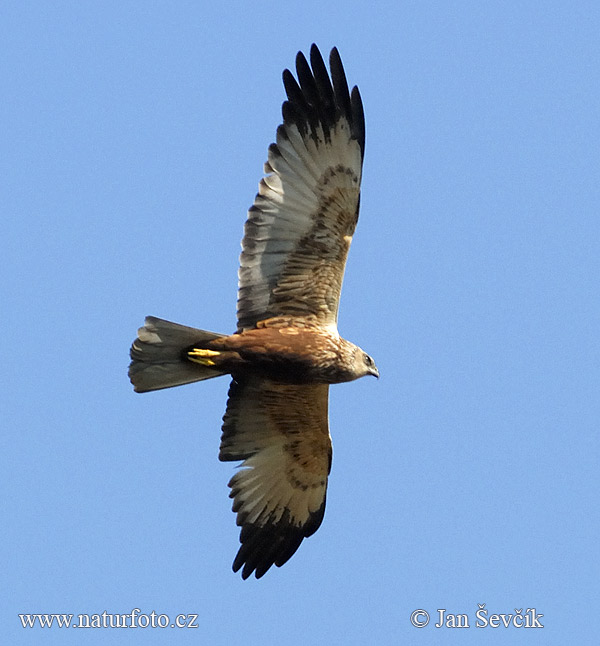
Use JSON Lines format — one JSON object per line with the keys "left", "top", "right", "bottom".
{"left": 219, "top": 377, "right": 331, "bottom": 579}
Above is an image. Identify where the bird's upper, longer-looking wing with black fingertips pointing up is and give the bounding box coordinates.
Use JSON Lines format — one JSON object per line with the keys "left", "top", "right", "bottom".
{"left": 237, "top": 45, "right": 365, "bottom": 331}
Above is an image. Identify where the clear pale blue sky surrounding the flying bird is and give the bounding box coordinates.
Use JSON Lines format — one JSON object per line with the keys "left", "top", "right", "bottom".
{"left": 0, "top": 0, "right": 600, "bottom": 646}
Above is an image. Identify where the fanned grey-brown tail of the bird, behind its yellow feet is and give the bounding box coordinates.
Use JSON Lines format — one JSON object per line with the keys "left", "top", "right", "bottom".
{"left": 129, "top": 316, "right": 226, "bottom": 393}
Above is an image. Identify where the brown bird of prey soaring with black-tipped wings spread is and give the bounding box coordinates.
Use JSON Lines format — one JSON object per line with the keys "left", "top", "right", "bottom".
{"left": 129, "top": 45, "right": 379, "bottom": 579}
